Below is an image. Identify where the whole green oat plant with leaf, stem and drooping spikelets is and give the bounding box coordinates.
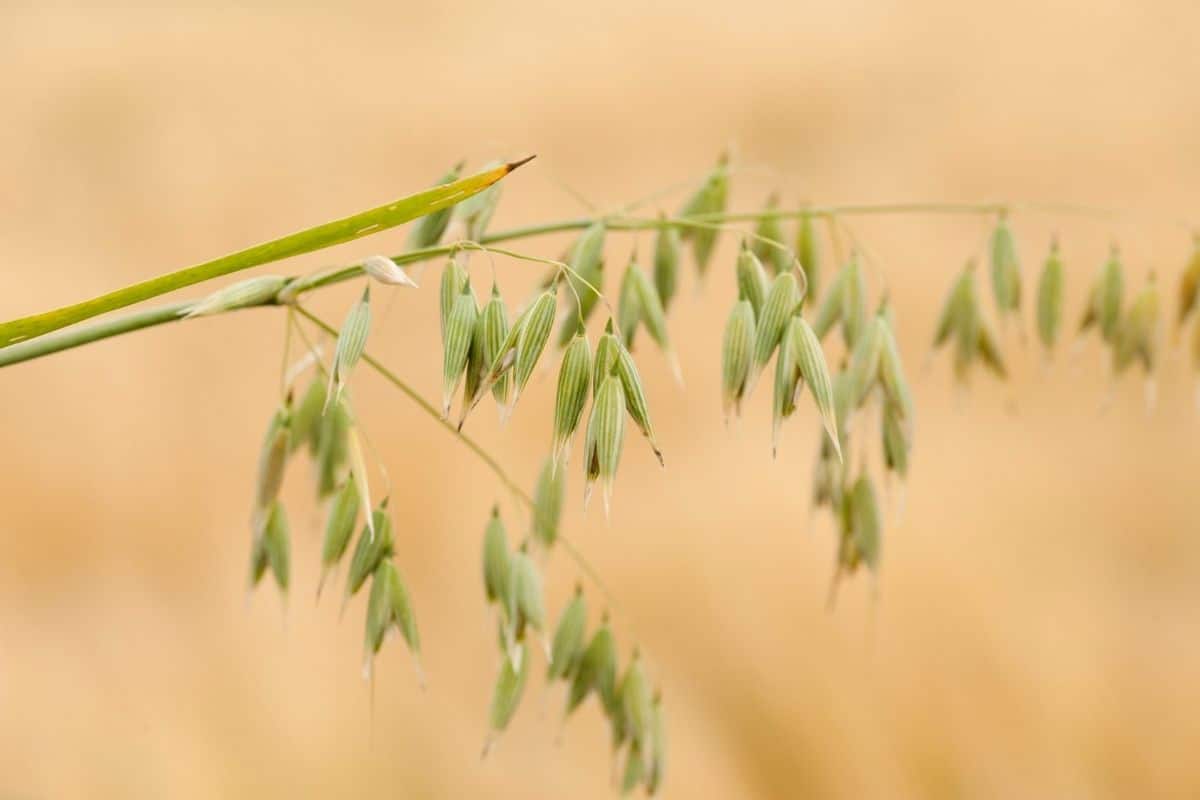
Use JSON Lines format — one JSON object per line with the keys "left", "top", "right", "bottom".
{"left": 0, "top": 156, "right": 1200, "bottom": 795}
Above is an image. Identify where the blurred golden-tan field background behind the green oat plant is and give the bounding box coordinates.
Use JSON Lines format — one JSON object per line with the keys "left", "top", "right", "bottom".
{"left": 0, "top": 0, "right": 1200, "bottom": 798}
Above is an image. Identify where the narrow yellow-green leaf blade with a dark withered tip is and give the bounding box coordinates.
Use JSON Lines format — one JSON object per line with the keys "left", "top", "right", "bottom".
{"left": 0, "top": 160, "right": 528, "bottom": 347}
